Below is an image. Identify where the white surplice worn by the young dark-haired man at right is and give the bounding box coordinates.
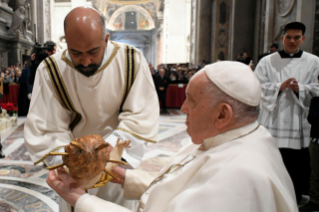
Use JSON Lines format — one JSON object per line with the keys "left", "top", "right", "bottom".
{"left": 255, "top": 52, "right": 319, "bottom": 149}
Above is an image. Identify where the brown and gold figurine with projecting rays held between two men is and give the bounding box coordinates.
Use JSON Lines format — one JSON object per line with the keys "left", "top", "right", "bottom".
{"left": 35, "top": 135, "right": 131, "bottom": 189}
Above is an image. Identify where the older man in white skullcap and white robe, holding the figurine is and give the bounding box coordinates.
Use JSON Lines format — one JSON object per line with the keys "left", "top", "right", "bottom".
{"left": 47, "top": 62, "right": 298, "bottom": 212}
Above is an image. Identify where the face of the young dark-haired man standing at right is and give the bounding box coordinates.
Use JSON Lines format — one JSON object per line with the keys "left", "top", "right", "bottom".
{"left": 281, "top": 29, "right": 305, "bottom": 54}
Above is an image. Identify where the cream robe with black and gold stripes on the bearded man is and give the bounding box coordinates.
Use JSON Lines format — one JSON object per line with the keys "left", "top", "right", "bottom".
{"left": 24, "top": 42, "right": 159, "bottom": 211}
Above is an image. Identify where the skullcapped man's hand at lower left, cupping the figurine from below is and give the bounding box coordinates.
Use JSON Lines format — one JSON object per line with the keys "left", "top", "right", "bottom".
{"left": 47, "top": 168, "right": 85, "bottom": 207}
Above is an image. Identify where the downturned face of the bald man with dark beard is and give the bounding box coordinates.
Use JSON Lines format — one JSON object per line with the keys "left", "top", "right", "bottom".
{"left": 65, "top": 26, "right": 108, "bottom": 77}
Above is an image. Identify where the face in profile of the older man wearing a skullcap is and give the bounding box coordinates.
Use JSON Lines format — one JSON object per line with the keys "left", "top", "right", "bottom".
{"left": 181, "top": 71, "right": 215, "bottom": 144}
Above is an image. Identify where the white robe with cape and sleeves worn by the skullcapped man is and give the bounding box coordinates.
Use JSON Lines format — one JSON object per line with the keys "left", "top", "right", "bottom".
{"left": 75, "top": 122, "right": 298, "bottom": 212}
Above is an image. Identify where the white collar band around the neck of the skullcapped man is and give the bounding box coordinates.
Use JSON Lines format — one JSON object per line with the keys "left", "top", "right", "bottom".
{"left": 198, "top": 121, "right": 259, "bottom": 151}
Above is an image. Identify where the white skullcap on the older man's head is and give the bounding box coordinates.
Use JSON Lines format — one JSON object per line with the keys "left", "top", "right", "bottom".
{"left": 204, "top": 61, "right": 261, "bottom": 106}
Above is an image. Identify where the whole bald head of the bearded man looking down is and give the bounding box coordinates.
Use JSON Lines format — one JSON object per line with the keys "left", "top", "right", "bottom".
{"left": 64, "top": 7, "right": 110, "bottom": 77}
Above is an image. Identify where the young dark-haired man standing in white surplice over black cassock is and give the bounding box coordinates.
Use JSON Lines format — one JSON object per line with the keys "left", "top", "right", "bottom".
{"left": 255, "top": 22, "right": 319, "bottom": 202}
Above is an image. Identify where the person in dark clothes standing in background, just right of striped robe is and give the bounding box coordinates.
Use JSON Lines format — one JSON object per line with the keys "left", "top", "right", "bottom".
{"left": 155, "top": 68, "right": 169, "bottom": 112}
